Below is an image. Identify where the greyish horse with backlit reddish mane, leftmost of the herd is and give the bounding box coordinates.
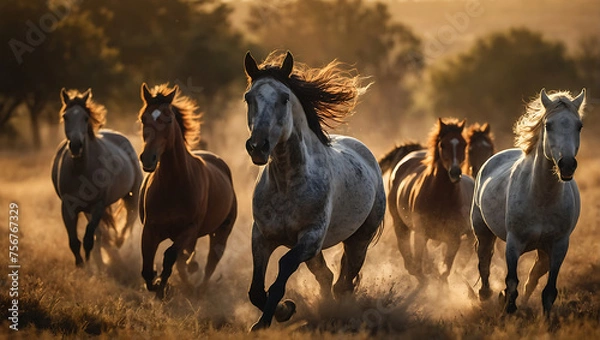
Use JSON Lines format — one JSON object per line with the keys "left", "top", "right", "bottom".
{"left": 52, "top": 88, "right": 142, "bottom": 266}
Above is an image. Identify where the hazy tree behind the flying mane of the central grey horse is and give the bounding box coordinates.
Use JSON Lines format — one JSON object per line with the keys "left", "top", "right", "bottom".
{"left": 247, "top": 0, "right": 423, "bottom": 131}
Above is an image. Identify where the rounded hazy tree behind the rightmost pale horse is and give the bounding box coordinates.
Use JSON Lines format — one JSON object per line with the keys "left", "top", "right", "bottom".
{"left": 428, "top": 28, "right": 581, "bottom": 133}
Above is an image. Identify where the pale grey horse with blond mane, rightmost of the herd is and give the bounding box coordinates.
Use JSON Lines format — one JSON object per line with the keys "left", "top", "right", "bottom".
{"left": 471, "top": 89, "right": 585, "bottom": 317}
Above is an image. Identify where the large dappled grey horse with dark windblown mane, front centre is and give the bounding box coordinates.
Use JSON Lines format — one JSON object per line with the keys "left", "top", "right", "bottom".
{"left": 244, "top": 52, "right": 385, "bottom": 331}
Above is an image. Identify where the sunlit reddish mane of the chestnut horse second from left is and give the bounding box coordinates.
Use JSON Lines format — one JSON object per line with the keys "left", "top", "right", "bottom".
{"left": 140, "top": 83, "right": 202, "bottom": 147}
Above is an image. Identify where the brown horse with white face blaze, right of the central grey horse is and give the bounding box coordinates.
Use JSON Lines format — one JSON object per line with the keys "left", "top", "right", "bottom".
{"left": 381, "top": 118, "right": 473, "bottom": 283}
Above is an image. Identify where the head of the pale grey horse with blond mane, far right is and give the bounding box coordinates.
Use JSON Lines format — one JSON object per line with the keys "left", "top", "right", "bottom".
{"left": 540, "top": 89, "right": 585, "bottom": 181}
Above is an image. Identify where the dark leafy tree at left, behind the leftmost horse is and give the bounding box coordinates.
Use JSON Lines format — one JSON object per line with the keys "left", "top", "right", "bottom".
{"left": 0, "top": 0, "right": 121, "bottom": 148}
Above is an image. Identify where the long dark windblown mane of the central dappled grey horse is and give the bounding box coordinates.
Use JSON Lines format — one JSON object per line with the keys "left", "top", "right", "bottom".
{"left": 248, "top": 51, "right": 369, "bottom": 145}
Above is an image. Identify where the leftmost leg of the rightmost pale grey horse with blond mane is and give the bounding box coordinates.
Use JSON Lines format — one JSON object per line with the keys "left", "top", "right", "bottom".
{"left": 471, "top": 206, "right": 496, "bottom": 300}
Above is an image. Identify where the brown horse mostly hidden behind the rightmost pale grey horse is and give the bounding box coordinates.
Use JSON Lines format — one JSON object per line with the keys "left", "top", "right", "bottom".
{"left": 467, "top": 123, "right": 496, "bottom": 178}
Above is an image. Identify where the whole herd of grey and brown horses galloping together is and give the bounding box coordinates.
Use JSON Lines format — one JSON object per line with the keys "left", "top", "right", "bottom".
{"left": 52, "top": 52, "right": 585, "bottom": 330}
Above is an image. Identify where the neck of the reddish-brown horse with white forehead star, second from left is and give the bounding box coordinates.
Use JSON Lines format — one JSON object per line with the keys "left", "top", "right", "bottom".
{"left": 156, "top": 126, "right": 201, "bottom": 183}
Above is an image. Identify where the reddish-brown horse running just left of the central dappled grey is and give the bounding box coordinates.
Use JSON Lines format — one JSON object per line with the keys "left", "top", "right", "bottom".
{"left": 139, "top": 83, "right": 237, "bottom": 299}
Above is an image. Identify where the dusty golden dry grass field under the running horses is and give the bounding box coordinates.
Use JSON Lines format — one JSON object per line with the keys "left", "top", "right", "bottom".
{"left": 0, "top": 107, "right": 600, "bottom": 339}
